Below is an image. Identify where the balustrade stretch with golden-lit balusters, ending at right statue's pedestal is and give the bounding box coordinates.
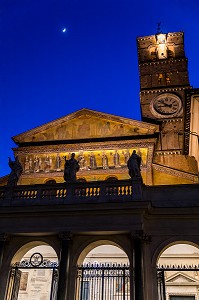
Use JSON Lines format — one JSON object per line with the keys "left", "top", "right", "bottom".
{"left": 0, "top": 180, "right": 142, "bottom": 206}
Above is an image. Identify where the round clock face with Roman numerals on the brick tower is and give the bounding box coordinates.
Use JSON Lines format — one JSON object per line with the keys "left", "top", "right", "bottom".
{"left": 151, "top": 93, "right": 182, "bottom": 118}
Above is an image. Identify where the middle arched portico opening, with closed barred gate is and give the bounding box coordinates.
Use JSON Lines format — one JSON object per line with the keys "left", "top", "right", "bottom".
{"left": 76, "top": 239, "right": 131, "bottom": 299}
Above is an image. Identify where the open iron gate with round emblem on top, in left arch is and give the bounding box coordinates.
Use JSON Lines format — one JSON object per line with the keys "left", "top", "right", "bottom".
{"left": 6, "top": 252, "right": 58, "bottom": 300}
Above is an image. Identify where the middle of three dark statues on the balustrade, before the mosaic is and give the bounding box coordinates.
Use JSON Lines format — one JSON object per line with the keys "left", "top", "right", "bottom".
{"left": 64, "top": 153, "right": 79, "bottom": 182}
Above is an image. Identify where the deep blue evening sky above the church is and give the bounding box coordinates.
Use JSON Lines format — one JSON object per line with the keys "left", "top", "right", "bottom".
{"left": 0, "top": 0, "right": 199, "bottom": 176}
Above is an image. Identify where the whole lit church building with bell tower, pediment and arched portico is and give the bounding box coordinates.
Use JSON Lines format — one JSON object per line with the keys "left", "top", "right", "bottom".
{"left": 0, "top": 32, "right": 199, "bottom": 300}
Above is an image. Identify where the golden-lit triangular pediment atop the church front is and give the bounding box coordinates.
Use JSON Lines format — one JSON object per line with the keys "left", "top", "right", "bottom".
{"left": 13, "top": 109, "right": 159, "bottom": 143}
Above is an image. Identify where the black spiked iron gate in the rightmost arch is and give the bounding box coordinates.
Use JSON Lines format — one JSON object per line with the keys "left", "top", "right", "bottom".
{"left": 157, "top": 265, "right": 199, "bottom": 300}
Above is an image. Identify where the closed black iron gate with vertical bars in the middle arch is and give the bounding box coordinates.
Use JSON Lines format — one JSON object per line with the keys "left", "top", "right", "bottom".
{"left": 77, "top": 264, "right": 130, "bottom": 300}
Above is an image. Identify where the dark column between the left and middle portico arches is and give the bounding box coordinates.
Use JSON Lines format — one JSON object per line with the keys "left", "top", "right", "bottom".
{"left": 57, "top": 232, "right": 72, "bottom": 300}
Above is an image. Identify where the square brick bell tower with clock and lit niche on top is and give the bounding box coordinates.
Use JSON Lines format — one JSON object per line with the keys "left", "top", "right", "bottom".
{"left": 137, "top": 32, "right": 191, "bottom": 150}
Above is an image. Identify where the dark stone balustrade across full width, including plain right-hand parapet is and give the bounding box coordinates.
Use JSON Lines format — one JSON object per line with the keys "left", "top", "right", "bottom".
{"left": 0, "top": 178, "right": 199, "bottom": 208}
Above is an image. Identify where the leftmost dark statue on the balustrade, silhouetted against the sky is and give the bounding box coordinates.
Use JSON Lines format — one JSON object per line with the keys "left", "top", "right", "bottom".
{"left": 7, "top": 156, "right": 23, "bottom": 186}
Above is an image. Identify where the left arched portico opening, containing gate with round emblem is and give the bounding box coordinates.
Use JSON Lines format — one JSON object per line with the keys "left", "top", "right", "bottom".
{"left": 6, "top": 241, "right": 58, "bottom": 300}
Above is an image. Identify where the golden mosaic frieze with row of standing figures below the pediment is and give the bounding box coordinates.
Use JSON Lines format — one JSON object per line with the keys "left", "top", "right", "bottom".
{"left": 19, "top": 148, "right": 148, "bottom": 173}
